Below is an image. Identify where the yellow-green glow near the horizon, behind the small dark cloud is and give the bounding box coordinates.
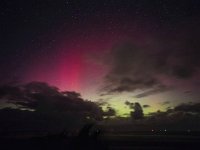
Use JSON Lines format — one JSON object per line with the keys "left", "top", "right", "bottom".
{"left": 87, "top": 91, "right": 198, "bottom": 117}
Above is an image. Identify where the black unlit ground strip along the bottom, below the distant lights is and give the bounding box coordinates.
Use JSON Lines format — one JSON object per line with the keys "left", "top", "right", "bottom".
{"left": 0, "top": 133, "right": 200, "bottom": 150}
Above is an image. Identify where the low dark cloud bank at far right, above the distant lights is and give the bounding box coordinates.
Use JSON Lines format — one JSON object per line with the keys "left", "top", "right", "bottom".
{"left": 145, "top": 103, "right": 200, "bottom": 131}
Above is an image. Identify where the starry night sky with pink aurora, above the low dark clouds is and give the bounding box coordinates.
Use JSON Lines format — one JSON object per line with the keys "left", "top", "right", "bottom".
{"left": 0, "top": 0, "right": 200, "bottom": 116}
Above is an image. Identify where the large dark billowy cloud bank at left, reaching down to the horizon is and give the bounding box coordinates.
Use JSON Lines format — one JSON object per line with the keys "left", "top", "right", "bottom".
{"left": 0, "top": 82, "right": 104, "bottom": 133}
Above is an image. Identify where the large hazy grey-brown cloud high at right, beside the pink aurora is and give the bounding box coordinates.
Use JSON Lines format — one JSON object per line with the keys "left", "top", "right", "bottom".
{"left": 104, "top": 24, "right": 200, "bottom": 98}
